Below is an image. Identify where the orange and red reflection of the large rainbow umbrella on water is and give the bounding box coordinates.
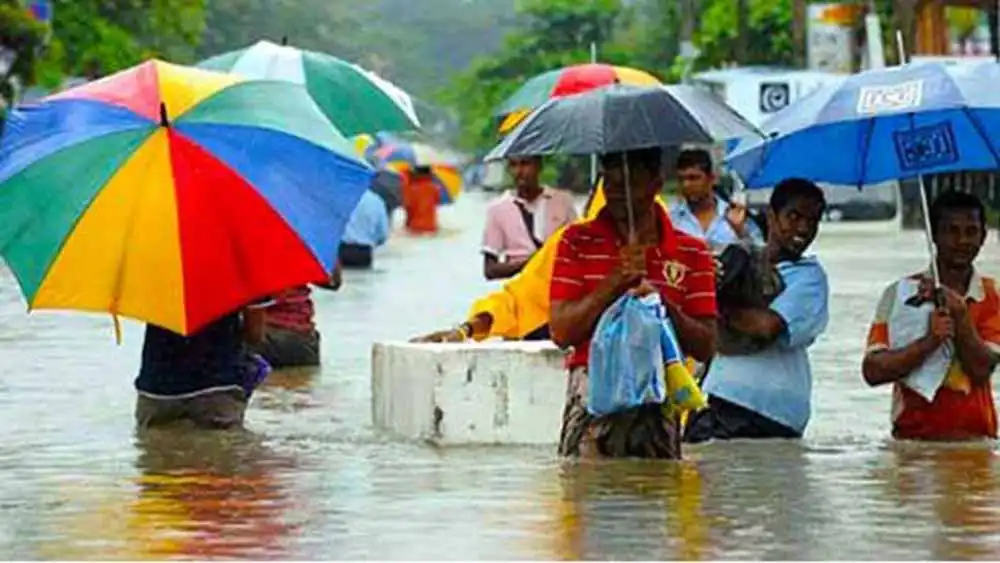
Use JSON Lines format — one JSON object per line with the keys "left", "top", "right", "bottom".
{"left": 132, "top": 431, "right": 295, "bottom": 558}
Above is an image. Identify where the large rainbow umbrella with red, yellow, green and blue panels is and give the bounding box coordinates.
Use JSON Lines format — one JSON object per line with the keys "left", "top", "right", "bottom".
{"left": 0, "top": 61, "right": 374, "bottom": 334}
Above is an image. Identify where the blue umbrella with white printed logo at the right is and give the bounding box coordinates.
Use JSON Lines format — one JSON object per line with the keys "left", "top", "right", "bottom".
{"left": 726, "top": 63, "right": 1000, "bottom": 188}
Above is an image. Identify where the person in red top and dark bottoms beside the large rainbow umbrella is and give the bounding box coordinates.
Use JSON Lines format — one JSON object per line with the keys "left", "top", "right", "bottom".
{"left": 254, "top": 262, "right": 342, "bottom": 369}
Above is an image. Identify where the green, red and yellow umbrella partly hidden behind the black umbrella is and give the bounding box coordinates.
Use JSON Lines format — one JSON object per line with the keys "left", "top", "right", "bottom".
{"left": 494, "top": 63, "right": 660, "bottom": 133}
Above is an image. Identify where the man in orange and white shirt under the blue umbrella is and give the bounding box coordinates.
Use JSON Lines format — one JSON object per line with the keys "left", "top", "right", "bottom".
{"left": 862, "top": 192, "right": 1000, "bottom": 440}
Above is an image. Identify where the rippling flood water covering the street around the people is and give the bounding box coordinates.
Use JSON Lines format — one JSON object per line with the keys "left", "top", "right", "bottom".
{"left": 0, "top": 193, "right": 1000, "bottom": 560}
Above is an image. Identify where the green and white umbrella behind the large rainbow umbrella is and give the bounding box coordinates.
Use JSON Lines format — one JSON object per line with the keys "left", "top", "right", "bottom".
{"left": 198, "top": 41, "right": 420, "bottom": 136}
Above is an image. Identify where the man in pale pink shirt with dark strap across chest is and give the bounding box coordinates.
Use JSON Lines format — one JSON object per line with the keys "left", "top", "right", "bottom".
{"left": 483, "top": 157, "right": 577, "bottom": 280}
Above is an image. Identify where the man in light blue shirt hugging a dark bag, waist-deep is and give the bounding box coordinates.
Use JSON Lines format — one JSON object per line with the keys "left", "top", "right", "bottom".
{"left": 684, "top": 179, "right": 830, "bottom": 442}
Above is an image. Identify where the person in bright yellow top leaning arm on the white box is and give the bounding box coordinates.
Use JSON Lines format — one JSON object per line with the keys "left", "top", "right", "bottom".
{"left": 414, "top": 183, "right": 667, "bottom": 342}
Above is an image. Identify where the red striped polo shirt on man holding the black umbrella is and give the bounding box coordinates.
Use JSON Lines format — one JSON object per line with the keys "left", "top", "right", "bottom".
{"left": 549, "top": 206, "right": 717, "bottom": 369}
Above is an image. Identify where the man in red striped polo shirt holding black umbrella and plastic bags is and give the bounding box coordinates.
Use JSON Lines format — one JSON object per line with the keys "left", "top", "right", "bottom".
{"left": 550, "top": 148, "right": 716, "bottom": 459}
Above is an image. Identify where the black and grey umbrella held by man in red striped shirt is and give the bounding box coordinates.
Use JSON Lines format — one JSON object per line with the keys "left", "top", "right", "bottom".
{"left": 486, "top": 84, "right": 763, "bottom": 160}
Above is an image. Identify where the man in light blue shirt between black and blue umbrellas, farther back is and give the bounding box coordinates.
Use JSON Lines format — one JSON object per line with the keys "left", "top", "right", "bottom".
{"left": 670, "top": 149, "right": 764, "bottom": 252}
